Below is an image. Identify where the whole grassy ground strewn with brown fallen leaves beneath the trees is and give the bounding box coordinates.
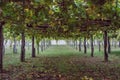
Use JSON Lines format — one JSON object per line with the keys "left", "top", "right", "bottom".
{"left": 0, "top": 46, "right": 120, "bottom": 80}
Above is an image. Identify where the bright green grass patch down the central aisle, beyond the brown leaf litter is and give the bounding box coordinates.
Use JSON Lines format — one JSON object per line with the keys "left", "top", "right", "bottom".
{"left": 41, "top": 46, "right": 80, "bottom": 57}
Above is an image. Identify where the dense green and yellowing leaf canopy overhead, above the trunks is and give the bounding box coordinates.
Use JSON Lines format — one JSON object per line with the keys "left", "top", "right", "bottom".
{"left": 0, "top": 0, "right": 120, "bottom": 37}
